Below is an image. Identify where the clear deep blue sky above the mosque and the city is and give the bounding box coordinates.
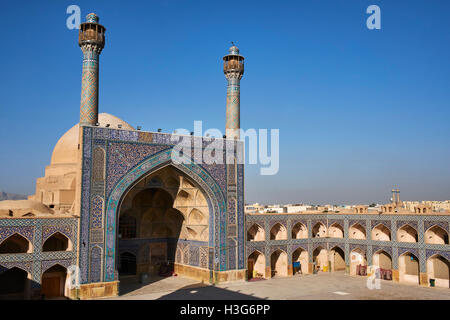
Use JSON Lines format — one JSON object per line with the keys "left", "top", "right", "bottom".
{"left": 0, "top": 0, "right": 450, "bottom": 204}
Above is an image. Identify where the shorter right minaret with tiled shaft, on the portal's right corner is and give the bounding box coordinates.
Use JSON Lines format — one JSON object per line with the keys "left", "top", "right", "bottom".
{"left": 223, "top": 43, "right": 244, "bottom": 139}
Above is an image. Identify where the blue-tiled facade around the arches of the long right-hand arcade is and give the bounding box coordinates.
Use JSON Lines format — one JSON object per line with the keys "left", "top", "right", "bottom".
{"left": 245, "top": 214, "right": 450, "bottom": 272}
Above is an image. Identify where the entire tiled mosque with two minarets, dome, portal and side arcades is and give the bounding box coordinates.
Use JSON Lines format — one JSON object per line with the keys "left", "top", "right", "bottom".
{"left": 0, "top": 13, "right": 450, "bottom": 299}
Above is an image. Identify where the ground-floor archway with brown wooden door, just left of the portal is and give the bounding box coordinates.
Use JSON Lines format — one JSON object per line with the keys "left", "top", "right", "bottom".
{"left": 41, "top": 264, "right": 67, "bottom": 299}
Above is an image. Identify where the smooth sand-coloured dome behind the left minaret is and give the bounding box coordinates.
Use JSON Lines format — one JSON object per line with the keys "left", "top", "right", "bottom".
{"left": 50, "top": 113, "right": 134, "bottom": 165}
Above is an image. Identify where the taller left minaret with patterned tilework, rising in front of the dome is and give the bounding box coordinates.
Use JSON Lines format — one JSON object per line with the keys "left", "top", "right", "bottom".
{"left": 78, "top": 13, "right": 106, "bottom": 126}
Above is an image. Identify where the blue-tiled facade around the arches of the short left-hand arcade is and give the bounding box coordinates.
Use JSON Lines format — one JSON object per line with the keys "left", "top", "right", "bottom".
{"left": 0, "top": 217, "right": 78, "bottom": 289}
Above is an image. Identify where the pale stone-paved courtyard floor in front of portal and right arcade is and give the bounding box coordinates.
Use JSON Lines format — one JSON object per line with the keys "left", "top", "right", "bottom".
{"left": 103, "top": 273, "right": 450, "bottom": 300}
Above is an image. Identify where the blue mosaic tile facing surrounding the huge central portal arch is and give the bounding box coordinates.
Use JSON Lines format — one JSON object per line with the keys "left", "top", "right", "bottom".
{"left": 80, "top": 126, "right": 245, "bottom": 283}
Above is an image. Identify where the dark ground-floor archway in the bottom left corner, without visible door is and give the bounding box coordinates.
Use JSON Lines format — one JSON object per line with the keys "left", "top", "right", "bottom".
{"left": 0, "top": 266, "right": 30, "bottom": 300}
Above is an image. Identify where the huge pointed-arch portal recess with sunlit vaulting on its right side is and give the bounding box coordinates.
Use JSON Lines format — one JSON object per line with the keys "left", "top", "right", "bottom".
{"left": 116, "top": 166, "right": 209, "bottom": 285}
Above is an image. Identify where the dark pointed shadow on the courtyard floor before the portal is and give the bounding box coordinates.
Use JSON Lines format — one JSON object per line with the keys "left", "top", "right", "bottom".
{"left": 156, "top": 285, "right": 264, "bottom": 300}
